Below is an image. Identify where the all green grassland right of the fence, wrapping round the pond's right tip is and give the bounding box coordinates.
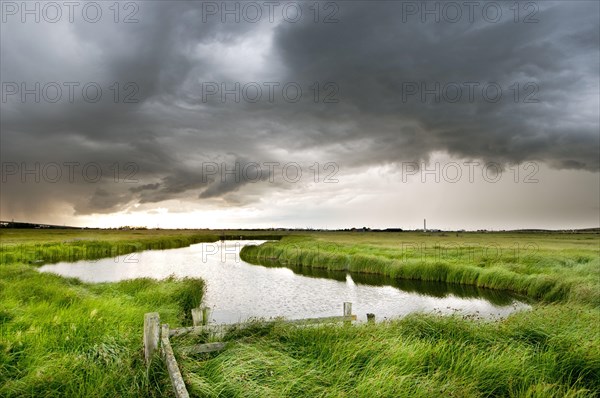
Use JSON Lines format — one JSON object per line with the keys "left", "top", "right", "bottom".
{"left": 190, "top": 233, "right": 600, "bottom": 397}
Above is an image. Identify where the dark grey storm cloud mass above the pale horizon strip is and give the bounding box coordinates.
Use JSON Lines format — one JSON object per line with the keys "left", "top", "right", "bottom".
{"left": 0, "top": 1, "right": 600, "bottom": 222}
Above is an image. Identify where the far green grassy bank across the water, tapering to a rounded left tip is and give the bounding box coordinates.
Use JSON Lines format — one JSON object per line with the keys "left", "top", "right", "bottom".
{"left": 241, "top": 233, "right": 600, "bottom": 305}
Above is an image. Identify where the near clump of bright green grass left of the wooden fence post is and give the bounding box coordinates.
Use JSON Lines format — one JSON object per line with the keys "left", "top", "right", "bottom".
{"left": 0, "top": 264, "right": 204, "bottom": 397}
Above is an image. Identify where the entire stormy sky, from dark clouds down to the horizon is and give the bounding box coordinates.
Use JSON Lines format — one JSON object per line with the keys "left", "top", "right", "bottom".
{"left": 0, "top": 0, "right": 600, "bottom": 230}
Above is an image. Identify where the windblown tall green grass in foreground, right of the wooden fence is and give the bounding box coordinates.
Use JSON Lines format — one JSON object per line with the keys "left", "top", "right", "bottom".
{"left": 179, "top": 305, "right": 600, "bottom": 397}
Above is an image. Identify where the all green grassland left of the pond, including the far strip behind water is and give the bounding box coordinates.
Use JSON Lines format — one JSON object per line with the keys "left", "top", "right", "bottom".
{"left": 0, "top": 230, "right": 216, "bottom": 397}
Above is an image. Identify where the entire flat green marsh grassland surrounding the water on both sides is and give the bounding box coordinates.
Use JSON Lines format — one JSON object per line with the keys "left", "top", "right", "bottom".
{"left": 0, "top": 229, "right": 600, "bottom": 397}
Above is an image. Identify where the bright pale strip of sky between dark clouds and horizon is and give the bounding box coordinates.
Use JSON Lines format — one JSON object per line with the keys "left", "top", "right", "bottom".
{"left": 8, "top": 153, "right": 600, "bottom": 231}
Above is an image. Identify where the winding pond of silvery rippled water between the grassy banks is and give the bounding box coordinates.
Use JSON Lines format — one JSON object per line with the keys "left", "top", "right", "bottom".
{"left": 40, "top": 241, "right": 530, "bottom": 323}
